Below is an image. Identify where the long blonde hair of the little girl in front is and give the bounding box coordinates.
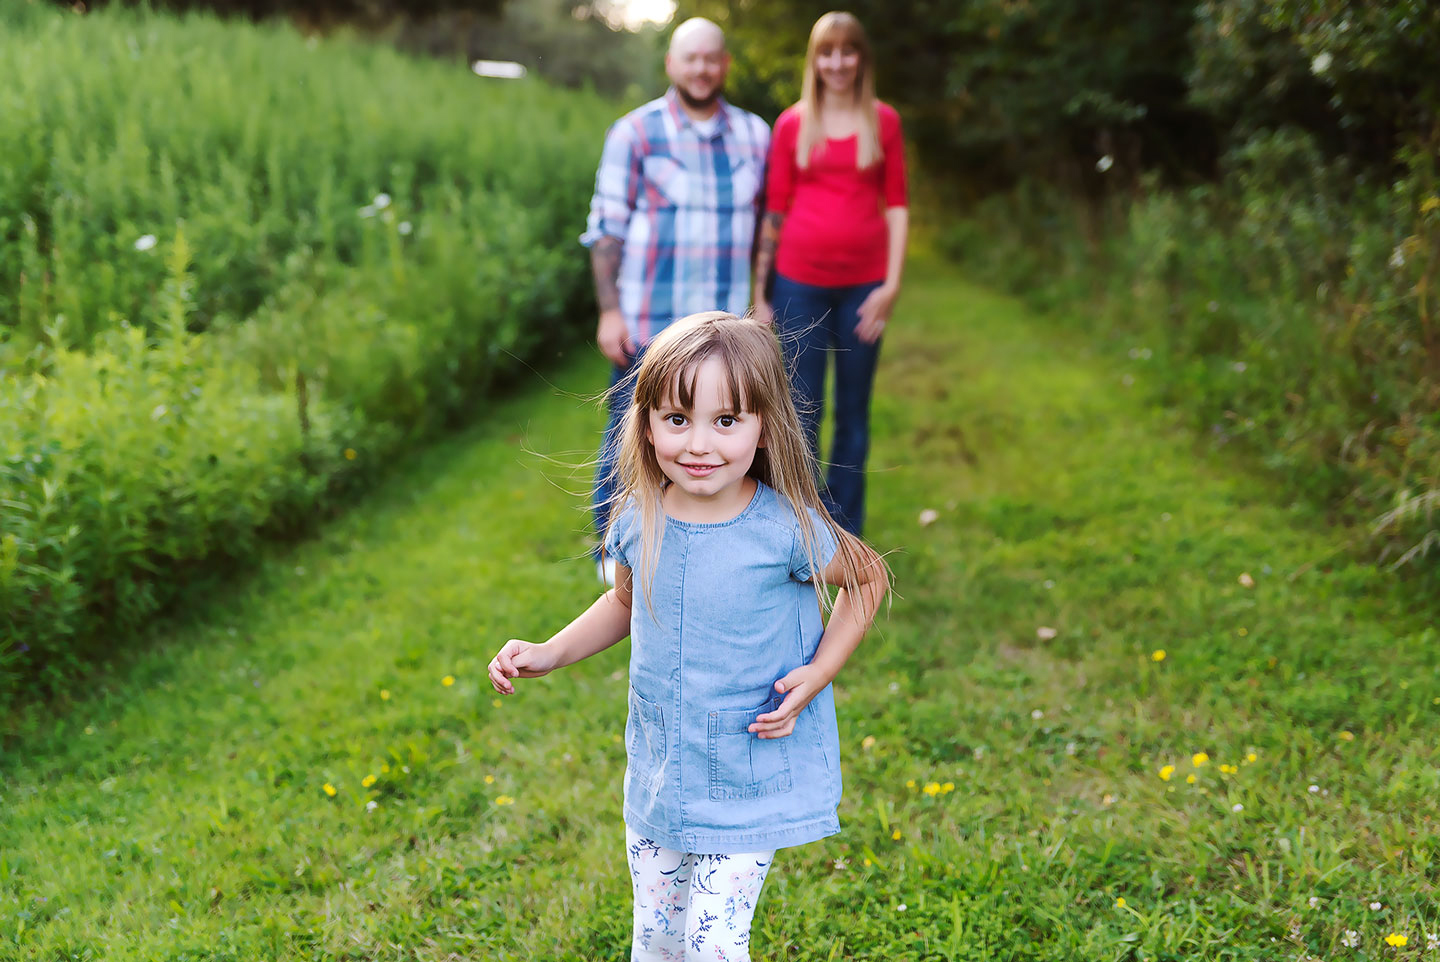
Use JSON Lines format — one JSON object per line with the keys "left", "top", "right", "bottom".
{"left": 611, "top": 311, "right": 888, "bottom": 608}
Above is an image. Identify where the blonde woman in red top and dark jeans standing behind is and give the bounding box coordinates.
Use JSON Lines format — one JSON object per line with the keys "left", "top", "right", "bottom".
{"left": 755, "top": 13, "right": 909, "bottom": 534}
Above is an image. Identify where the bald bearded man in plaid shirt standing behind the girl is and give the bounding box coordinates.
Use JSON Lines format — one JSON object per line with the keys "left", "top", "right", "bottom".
{"left": 580, "top": 17, "right": 770, "bottom": 582}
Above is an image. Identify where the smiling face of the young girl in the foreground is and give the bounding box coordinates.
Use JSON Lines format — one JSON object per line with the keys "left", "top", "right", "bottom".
{"left": 645, "top": 357, "right": 765, "bottom": 521}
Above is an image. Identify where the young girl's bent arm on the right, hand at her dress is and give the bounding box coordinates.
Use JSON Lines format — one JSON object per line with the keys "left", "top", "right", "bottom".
{"left": 750, "top": 534, "right": 890, "bottom": 739}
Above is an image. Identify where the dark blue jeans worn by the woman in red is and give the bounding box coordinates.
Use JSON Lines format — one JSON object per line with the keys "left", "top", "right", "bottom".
{"left": 770, "top": 274, "right": 880, "bottom": 534}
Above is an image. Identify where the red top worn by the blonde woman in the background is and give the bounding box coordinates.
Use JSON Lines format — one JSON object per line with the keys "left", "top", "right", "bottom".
{"left": 765, "top": 102, "right": 906, "bottom": 287}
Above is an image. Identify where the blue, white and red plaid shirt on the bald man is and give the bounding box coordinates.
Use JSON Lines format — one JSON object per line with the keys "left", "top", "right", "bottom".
{"left": 580, "top": 89, "right": 770, "bottom": 344}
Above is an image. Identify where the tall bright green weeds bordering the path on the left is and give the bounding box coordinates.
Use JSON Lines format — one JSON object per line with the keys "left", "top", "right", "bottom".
{"left": 0, "top": 3, "right": 613, "bottom": 703}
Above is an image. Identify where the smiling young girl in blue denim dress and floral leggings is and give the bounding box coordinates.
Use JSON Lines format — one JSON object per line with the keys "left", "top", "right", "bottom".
{"left": 490, "top": 313, "right": 888, "bottom": 962}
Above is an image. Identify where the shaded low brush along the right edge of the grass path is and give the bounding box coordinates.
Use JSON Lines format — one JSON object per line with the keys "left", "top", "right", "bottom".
{"left": 945, "top": 130, "right": 1440, "bottom": 573}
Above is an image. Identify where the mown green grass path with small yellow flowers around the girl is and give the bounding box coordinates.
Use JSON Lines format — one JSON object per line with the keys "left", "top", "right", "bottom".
{"left": 0, "top": 258, "right": 1440, "bottom": 961}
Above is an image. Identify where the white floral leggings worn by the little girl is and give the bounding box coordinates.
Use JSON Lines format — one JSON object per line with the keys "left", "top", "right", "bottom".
{"left": 625, "top": 828, "right": 775, "bottom": 962}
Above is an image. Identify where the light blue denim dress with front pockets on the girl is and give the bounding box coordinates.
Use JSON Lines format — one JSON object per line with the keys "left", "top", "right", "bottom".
{"left": 605, "top": 482, "right": 841, "bottom": 855}
